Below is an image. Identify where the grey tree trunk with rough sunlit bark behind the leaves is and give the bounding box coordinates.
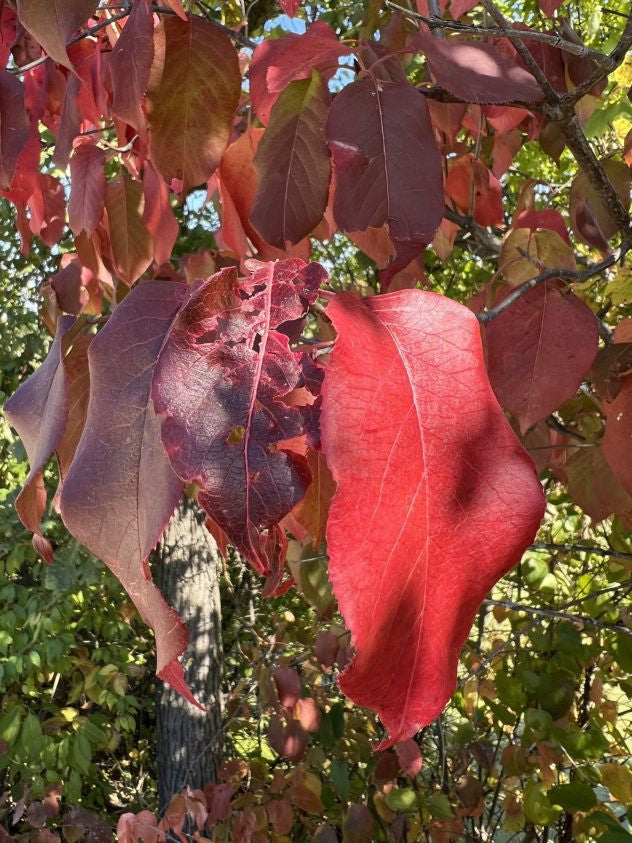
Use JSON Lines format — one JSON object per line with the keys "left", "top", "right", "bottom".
{"left": 155, "top": 498, "right": 222, "bottom": 810}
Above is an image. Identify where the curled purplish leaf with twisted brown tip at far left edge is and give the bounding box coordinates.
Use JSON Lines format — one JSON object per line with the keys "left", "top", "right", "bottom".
{"left": 4, "top": 316, "right": 75, "bottom": 563}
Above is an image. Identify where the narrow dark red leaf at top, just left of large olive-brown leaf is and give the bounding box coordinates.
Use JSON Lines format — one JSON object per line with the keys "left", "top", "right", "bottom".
{"left": 108, "top": 0, "right": 154, "bottom": 131}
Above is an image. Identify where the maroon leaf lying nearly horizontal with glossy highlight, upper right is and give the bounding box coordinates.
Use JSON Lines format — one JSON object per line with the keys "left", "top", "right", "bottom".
{"left": 407, "top": 30, "right": 544, "bottom": 103}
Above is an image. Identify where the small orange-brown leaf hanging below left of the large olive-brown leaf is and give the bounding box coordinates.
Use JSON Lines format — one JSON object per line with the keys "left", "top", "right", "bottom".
{"left": 105, "top": 171, "right": 154, "bottom": 286}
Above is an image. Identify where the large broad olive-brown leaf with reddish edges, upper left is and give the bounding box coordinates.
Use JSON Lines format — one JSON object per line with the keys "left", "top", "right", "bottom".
{"left": 147, "top": 16, "right": 241, "bottom": 193}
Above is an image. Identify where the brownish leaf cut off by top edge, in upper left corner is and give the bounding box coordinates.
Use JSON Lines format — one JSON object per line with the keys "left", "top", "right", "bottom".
{"left": 18, "top": 0, "right": 98, "bottom": 70}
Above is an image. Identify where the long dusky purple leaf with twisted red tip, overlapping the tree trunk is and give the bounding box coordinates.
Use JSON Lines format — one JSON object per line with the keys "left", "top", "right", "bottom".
{"left": 61, "top": 281, "right": 199, "bottom": 702}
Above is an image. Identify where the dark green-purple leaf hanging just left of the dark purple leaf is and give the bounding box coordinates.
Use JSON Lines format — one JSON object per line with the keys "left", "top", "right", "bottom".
{"left": 250, "top": 70, "right": 331, "bottom": 249}
